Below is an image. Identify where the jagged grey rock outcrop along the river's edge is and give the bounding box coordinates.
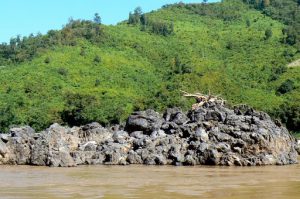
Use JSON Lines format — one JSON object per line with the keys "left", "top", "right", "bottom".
{"left": 0, "top": 102, "right": 300, "bottom": 167}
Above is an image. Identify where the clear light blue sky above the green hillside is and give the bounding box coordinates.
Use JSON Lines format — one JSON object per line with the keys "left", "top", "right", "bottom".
{"left": 0, "top": 0, "right": 218, "bottom": 43}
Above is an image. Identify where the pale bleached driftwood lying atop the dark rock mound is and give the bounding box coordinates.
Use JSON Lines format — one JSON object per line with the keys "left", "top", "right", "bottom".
{"left": 181, "top": 91, "right": 225, "bottom": 110}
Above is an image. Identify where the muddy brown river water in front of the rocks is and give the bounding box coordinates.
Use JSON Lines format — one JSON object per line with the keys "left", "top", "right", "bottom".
{"left": 0, "top": 159, "right": 300, "bottom": 199}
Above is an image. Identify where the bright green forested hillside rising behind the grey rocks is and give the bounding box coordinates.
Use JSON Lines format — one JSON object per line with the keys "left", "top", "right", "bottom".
{"left": 0, "top": 0, "right": 300, "bottom": 131}
